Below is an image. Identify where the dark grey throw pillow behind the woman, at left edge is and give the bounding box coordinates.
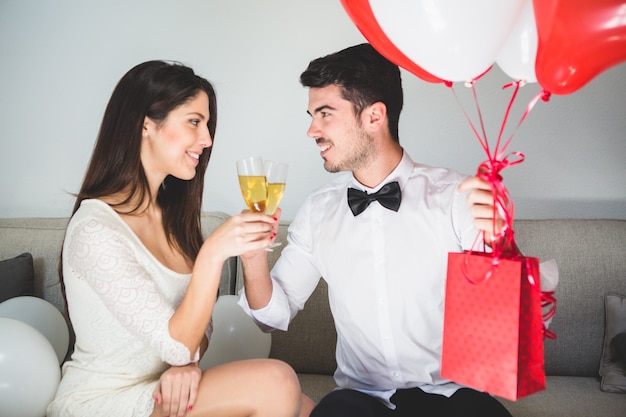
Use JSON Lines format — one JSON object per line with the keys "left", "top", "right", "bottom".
{"left": 0, "top": 252, "right": 35, "bottom": 303}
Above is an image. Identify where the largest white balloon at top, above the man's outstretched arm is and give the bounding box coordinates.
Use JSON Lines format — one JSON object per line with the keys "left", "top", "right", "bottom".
{"left": 370, "top": 0, "right": 524, "bottom": 81}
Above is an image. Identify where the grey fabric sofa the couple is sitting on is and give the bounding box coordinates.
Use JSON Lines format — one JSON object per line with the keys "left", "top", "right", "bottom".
{"left": 0, "top": 212, "right": 626, "bottom": 417}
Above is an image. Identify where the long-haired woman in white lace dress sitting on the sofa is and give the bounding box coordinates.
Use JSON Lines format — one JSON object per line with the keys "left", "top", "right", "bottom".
{"left": 48, "top": 61, "right": 310, "bottom": 417}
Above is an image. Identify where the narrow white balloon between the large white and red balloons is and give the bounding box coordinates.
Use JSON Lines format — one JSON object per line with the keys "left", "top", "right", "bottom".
{"left": 496, "top": 0, "right": 538, "bottom": 83}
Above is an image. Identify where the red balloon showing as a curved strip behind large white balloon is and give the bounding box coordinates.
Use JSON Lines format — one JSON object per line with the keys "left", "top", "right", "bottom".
{"left": 341, "top": 0, "right": 445, "bottom": 83}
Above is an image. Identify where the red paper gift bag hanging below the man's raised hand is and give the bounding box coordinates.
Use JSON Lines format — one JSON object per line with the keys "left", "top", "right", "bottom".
{"left": 441, "top": 247, "right": 546, "bottom": 400}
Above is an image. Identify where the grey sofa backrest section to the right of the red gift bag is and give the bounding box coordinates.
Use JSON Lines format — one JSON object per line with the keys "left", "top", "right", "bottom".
{"left": 514, "top": 219, "right": 626, "bottom": 376}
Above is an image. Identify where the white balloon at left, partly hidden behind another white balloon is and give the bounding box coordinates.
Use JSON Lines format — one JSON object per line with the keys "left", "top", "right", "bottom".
{"left": 0, "top": 296, "right": 70, "bottom": 362}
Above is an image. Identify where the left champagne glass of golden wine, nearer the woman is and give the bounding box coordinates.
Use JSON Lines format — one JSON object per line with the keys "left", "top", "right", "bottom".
{"left": 237, "top": 156, "right": 267, "bottom": 213}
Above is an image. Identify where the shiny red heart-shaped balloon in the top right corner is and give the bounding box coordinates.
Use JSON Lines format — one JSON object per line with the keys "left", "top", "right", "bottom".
{"left": 533, "top": 0, "right": 626, "bottom": 94}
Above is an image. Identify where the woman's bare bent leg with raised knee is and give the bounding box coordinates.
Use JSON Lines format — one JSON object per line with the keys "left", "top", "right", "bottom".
{"left": 152, "top": 359, "right": 300, "bottom": 417}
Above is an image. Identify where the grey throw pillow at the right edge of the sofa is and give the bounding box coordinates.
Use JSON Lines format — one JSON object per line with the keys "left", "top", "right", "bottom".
{"left": 600, "top": 294, "right": 626, "bottom": 393}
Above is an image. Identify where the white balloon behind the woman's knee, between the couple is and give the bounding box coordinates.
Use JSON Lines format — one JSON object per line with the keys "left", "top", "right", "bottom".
{"left": 199, "top": 295, "right": 272, "bottom": 370}
